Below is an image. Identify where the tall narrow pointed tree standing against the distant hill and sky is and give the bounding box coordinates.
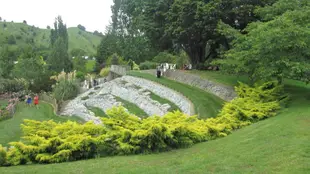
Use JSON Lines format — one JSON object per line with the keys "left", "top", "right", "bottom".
{"left": 48, "top": 16, "right": 73, "bottom": 72}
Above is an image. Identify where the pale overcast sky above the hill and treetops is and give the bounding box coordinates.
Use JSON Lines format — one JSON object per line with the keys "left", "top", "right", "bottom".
{"left": 0, "top": 0, "right": 113, "bottom": 32}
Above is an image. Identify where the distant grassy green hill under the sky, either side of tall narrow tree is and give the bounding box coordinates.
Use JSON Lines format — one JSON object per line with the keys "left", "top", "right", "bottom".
{"left": 0, "top": 22, "right": 101, "bottom": 55}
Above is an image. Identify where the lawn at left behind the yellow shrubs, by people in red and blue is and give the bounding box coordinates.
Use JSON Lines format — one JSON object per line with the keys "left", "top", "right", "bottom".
{"left": 0, "top": 102, "right": 82, "bottom": 145}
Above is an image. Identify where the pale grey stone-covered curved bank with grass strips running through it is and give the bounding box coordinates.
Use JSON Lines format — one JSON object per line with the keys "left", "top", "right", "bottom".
{"left": 60, "top": 76, "right": 194, "bottom": 124}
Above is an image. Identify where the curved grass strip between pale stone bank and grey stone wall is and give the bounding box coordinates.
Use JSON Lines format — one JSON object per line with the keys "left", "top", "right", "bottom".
{"left": 129, "top": 71, "right": 224, "bottom": 118}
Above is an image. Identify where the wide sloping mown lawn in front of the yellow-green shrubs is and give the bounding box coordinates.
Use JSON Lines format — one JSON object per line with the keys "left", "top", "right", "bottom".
{"left": 0, "top": 81, "right": 310, "bottom": 174}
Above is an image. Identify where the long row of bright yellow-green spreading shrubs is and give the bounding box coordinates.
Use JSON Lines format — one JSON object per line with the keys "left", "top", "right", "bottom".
{"left": 0, "top": 82, "right": 285, "bottom": 165}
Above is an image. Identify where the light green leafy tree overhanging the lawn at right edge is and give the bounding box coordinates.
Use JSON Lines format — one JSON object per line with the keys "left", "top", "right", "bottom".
{"left": 215, "top": 0, "right": 310, "bottom": 82}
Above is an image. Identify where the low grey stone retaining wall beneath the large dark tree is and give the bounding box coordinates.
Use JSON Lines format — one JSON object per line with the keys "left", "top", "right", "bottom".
{"left": 145, "top": 70, "right": 236, "bottom": 101}
